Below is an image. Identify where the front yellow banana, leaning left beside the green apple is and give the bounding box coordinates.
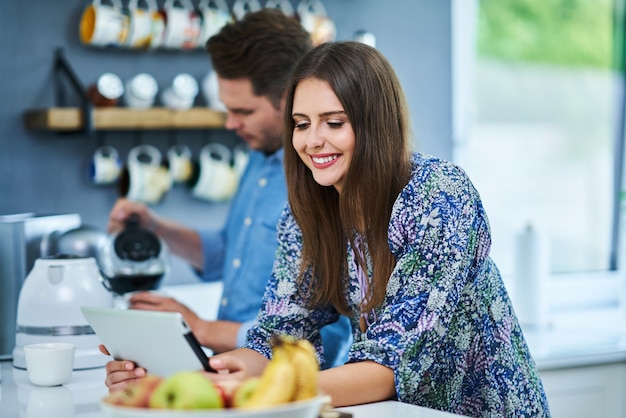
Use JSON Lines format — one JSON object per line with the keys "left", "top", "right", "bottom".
{"left": 242, "top": 343, "right": 296, "bottom": 409}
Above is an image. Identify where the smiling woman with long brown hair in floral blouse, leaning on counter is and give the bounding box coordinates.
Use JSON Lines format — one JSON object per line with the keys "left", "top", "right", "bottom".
{"left": 109, "top": 42, "right": 549, "bottom": 417}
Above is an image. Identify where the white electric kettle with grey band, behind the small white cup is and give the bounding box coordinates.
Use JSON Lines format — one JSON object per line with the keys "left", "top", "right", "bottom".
{"left": 13, "top": 255, "right": 113, "bottom": 369}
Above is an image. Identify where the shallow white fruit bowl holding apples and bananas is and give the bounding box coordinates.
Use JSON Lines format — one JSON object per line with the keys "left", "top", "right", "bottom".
{"left": 100, "top": 396, "right": 328, "bottom": 418}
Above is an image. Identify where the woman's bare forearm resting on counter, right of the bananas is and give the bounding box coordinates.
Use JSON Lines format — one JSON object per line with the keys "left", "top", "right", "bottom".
{"left": 319, "top": 360, "right": 396, "bottom": 407}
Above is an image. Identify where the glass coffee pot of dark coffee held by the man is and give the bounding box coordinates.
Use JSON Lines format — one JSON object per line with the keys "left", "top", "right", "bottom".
{"left": 98, "top": 214, "right": 168, "bottom": 296}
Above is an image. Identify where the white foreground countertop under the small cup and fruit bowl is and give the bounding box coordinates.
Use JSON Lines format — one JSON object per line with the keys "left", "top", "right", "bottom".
{"left": 0, "top": 361, "right": 458, "bottom": 418}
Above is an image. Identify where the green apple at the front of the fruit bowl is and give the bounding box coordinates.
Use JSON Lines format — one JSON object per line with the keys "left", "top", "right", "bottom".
{"left": 149, "top": 371, "right": 224, "bottom": 409}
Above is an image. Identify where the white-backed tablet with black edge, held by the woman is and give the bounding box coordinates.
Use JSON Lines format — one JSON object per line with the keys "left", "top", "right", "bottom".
{"left": 80, "top": 306, "right": 214, "bottom": 377}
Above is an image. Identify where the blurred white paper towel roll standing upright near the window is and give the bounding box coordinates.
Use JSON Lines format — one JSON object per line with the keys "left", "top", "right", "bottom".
{"left": 513, "top": 224, "right": 550, "bottom": 329}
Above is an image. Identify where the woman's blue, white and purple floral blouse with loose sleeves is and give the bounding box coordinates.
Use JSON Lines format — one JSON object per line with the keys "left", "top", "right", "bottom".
{"left": 246, "top": 153, "right": 550, "bottom": 417}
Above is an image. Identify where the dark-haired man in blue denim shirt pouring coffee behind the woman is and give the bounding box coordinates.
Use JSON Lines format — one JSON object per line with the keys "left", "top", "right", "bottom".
{"left": 109, "top": 9, "right": 351, "bottom": 368}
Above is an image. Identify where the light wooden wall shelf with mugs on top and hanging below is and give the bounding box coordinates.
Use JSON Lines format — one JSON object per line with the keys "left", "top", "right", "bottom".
{"left": 24, "top": 107, "right": 226, "bottom": 131}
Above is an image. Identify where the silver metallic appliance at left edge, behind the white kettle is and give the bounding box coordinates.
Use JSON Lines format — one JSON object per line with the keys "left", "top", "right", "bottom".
{"left": 0, "top": 213, "right": 81, "bottom": 360}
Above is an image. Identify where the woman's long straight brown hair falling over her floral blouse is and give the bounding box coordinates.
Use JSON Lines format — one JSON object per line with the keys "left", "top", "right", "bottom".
{"left": 284, "top": 42, "right": 411, "bottom": 314}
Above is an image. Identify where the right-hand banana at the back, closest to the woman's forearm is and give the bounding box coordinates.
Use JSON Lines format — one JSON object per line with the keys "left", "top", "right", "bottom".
{"left": 283, "top": 340, "right": 319, "bottom": 401}
